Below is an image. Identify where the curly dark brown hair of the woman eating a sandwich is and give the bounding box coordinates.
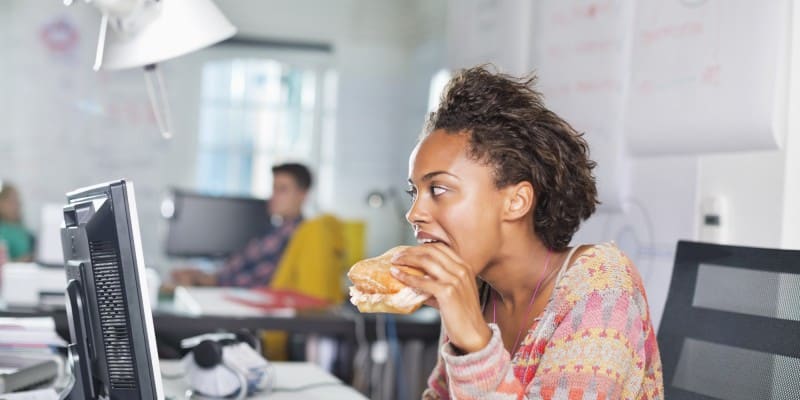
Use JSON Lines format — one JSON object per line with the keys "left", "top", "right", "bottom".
{"left": 423, "top": 66, "right": 599, "bottom": 251}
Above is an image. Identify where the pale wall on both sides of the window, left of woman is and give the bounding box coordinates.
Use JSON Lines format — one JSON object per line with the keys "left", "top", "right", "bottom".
{"left": 0, "top": 0, "right": 444, "bottom": 265}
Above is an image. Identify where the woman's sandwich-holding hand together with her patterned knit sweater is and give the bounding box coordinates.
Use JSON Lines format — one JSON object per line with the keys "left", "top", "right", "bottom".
{"left": 395, "top": 245, "right": 646, "bottom": 399}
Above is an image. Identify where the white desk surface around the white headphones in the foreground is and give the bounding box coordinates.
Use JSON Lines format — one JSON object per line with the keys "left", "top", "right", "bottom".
{"left": 160, "top": 360, "right": 366, "bottom": 400}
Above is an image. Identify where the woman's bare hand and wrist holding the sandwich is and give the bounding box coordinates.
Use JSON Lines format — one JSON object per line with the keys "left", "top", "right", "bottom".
{"left": 391, "top": 243, "right": 492, "bottom": 353}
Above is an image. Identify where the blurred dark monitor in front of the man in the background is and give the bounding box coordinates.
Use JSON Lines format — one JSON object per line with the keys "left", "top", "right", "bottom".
{"left": 162, "top": 190, "right": 269, "bottom": 258}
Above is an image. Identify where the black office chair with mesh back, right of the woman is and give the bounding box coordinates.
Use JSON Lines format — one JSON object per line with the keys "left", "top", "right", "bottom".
{"left": 658, "top": 241, "right": 800, "bottom": 400}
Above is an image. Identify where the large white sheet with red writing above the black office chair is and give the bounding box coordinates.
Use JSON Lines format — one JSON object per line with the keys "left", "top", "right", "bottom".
{"left": 626, "top": 0, "right": 791, "bottom": 155}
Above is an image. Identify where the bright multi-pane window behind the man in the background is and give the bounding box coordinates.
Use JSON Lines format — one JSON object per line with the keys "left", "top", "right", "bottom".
{"left": 197, "top": 58, "right": 336, "bottom": 197}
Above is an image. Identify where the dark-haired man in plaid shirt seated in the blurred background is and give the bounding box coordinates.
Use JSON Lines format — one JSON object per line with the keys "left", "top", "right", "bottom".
{"left": 172, "top": 163, "right": 311, "bottom": 287}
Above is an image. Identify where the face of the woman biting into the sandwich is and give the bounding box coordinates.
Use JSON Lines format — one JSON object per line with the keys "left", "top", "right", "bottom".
{"left": 406, "top": 130, "right": 503, "bottom": 274}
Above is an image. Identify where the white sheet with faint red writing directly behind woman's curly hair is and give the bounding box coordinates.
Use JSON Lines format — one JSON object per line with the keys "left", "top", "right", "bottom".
{"left": 533, "top": 0, "right": 633, "bottom": 210}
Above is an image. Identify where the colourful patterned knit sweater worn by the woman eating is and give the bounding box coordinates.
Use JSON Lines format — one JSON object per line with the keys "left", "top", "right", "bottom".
{"left": 424, "top": 292, "right": 649, "bottom": 399}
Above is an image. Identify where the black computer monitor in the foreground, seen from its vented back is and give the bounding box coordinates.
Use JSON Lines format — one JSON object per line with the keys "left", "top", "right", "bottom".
{"left": 61, "top": 180, "right": 164, "bottom": 400}
